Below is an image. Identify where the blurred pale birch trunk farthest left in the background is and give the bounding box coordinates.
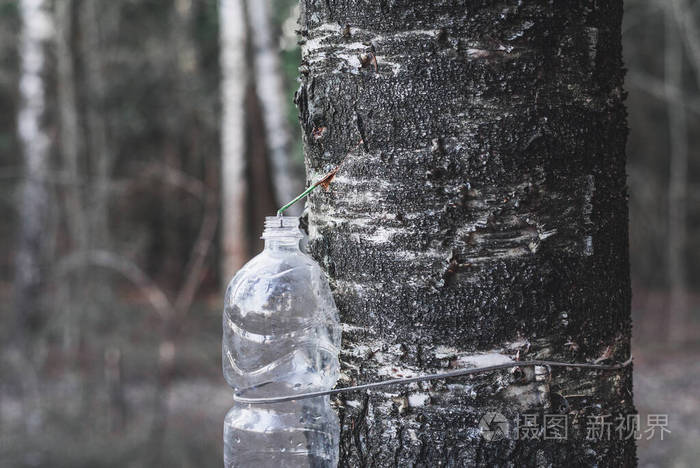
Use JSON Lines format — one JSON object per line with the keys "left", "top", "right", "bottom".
{"left": 15, "top": 0, "right": 52, "bottom": 331}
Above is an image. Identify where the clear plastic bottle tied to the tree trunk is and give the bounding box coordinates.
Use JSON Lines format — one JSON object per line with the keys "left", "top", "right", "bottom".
{"left": 222, "top": 216, "right": 340, "bottom": 468}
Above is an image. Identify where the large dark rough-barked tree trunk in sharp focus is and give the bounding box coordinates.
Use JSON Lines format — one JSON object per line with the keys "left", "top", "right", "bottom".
{"left": 297, "top": 0, "right": 635, "bottom": 466}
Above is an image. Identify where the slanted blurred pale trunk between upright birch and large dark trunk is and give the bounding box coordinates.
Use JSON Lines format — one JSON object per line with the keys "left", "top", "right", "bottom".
{"left": 247, "top": 0, "right": 300, "bottom": 210}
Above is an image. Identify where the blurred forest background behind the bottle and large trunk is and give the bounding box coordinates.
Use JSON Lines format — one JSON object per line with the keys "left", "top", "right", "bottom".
{"left": 0, "top": 0, "right": 700, "bottom": 467}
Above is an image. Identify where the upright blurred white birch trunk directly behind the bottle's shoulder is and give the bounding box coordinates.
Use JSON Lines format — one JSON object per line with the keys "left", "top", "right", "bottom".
{"left": 219, "top": 0, "right": 248, "bottom": 284}
